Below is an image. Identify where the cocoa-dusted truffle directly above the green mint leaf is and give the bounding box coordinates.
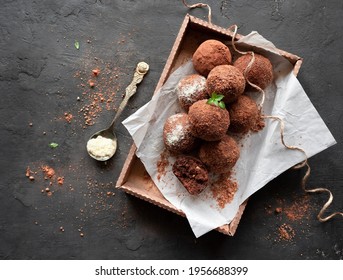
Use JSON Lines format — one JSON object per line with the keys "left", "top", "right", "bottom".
{"left": 206, "top": 65, "right": 245, "bottom": 103}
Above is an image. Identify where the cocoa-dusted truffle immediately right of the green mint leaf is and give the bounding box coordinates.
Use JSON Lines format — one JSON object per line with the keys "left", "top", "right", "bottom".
{"left": 229, "top": 94, "right": 259, "bottom": 133}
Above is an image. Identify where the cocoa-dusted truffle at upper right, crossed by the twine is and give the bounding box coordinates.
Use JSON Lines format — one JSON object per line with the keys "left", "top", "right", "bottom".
{"left": 234, "top": 53, "right": 273, "bottom": 89}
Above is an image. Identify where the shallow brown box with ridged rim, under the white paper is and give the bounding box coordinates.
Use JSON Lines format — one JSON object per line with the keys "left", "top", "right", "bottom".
{"left": 116, "top": 14, "right": 302, "bottom": 236}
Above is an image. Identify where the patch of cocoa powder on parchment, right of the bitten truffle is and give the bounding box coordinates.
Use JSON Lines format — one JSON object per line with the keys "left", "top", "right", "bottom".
{"left": 211, "top": 173, "right": 238, "bottom": 208}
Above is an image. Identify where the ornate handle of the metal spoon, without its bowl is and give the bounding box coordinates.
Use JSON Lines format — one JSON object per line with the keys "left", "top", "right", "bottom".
{"left": 110, "top": 62, "right": 149, "bottom": 129}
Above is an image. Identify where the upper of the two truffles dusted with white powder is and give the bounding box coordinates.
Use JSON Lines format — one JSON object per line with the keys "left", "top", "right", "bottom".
{"left": 176, "top": 74, "right": 208, "bottom": 111}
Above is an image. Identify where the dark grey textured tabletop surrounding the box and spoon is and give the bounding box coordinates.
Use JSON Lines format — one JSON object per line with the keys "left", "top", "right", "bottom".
{"left": 0, "top": 0, "right": 343, "bottom": 259}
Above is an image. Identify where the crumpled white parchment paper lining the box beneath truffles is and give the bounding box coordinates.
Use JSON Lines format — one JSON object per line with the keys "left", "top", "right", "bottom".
{"left": 123, "top": 32, "right": 336, "bottom": 237}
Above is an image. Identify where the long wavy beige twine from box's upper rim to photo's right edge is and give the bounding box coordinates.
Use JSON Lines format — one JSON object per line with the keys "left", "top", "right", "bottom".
{"left": 229, "top": 25, "right": 343, "bottom": 222}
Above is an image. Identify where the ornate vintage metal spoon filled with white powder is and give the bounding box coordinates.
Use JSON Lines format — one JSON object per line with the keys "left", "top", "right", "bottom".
{"left": 87, "top": 62, "right": 149, "bottom": 161}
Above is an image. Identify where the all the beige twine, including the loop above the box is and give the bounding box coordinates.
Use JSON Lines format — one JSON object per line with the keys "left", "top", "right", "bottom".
{"left": 182, "top": 0, "right": 343, "bottom": 222}
